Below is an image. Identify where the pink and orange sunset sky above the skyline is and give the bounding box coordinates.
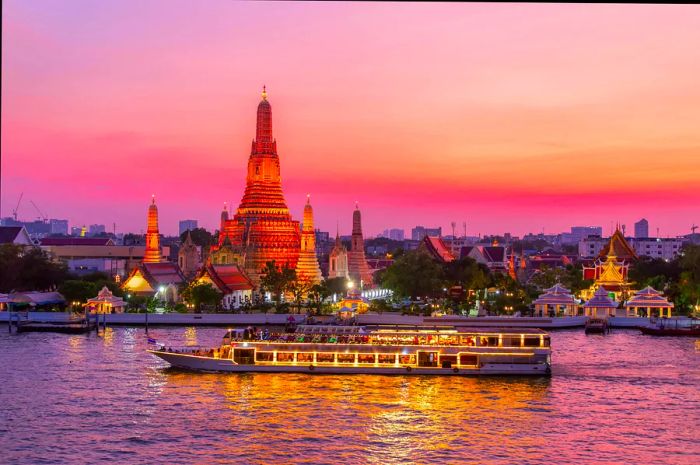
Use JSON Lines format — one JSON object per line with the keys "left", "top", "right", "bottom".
{"left": 1, "top": 0, "right": 700, "bottom": 236}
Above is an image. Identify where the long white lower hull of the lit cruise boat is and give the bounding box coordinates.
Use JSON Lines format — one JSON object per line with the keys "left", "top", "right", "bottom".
{"left": 149, "top": 350, "right": 551, "bottom": 376}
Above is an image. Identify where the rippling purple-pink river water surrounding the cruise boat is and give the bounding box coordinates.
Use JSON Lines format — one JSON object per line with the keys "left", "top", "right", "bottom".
{"left": 0, "top": 328, "right": 700, "bottom": 465}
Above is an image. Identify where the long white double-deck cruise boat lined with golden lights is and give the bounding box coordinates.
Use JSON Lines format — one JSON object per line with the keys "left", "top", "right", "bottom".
{"left": 149, "top": 326, "right": 551, "bottom": 376}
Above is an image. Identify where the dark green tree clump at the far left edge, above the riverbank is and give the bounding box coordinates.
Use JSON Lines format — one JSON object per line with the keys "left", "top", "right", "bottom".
{"left": 0, "top": 244, "right": 68, "bottom": 293}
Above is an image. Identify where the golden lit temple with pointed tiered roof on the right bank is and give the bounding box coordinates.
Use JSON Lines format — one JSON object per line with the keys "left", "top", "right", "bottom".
{"left": 581, "top": 228, "right": 637, "bottom": 300}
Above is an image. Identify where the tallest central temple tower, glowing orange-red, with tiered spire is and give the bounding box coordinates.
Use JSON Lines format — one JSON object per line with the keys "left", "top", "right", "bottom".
{"left": 211, "top": 88, "right": 301, "bottom": 285}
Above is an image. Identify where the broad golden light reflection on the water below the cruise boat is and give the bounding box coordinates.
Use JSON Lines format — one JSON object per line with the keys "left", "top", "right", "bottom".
{"left": 159, "top": 372, "right": 549, "bottom": 464}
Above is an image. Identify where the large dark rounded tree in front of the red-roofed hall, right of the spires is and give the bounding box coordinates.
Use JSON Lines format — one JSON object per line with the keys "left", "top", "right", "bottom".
{"left": 382, "top": 250, "right": 445, "bottom": 298}
